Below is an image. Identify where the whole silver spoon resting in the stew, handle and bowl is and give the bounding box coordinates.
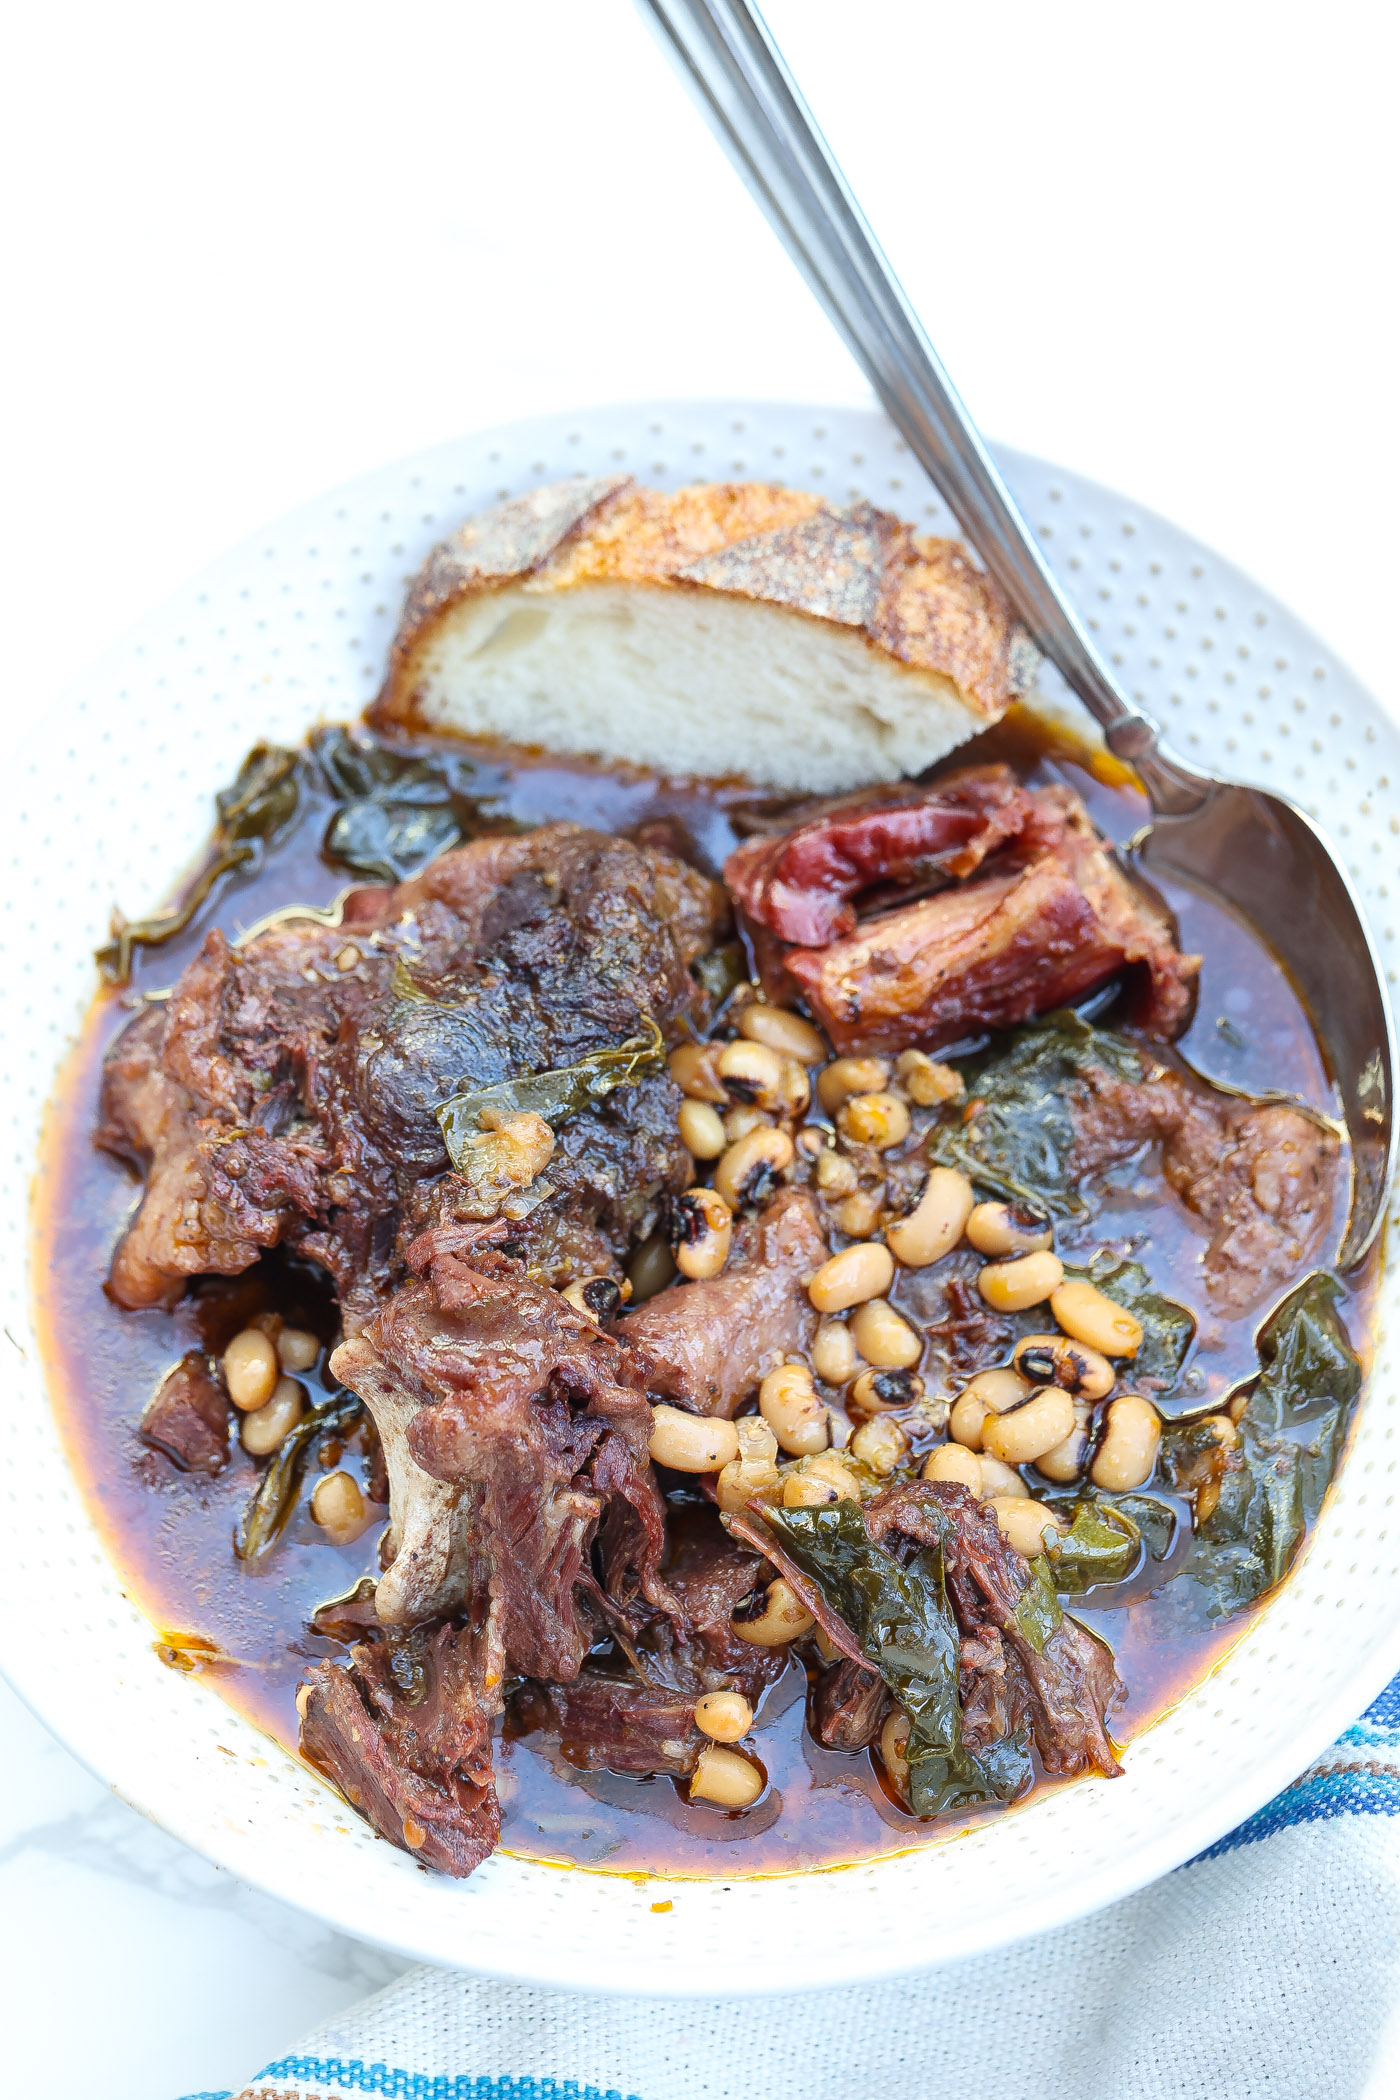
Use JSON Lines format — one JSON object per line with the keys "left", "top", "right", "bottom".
{"left": 642, "top": 0, "right": 1396, "bottom": 1268}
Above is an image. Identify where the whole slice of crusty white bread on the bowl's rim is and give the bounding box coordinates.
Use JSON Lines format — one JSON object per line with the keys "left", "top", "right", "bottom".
{"left": 372, "top": 475, "right": 1037, "bottom": 792}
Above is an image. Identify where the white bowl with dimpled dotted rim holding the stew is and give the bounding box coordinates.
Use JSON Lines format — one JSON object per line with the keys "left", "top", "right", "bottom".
{"left": 0, "top": 403, "right": 1400, "bottom": 1997}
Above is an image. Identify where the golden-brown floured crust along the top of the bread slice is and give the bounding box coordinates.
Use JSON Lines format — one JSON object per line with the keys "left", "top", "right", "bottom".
{"left": 372, "top": 475, "right": 1035, "bottom": 727}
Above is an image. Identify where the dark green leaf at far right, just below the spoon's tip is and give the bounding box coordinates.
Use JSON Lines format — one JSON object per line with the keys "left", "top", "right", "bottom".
{"left": 1163, "top": 1275, "right": 1360, "bottom": 1619}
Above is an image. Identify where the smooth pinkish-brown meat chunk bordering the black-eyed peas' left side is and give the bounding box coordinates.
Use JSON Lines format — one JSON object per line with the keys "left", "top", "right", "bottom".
{"left": 623, "top": 1189, "right": 829, "bottom": 1415}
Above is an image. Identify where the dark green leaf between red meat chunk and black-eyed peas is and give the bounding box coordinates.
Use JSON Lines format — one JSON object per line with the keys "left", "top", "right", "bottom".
{"left": 930, "top": 1012, "right": 1144, "bottom": 1218}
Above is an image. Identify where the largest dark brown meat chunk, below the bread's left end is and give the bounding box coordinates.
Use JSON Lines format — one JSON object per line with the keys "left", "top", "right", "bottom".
{"left": 99, "top": 823, "right": 728, "bottom": 1327}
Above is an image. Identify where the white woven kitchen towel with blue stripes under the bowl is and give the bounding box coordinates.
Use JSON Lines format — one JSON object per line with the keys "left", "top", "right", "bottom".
{"left": 202, "top": 1678, "right": 1400, "bottom": 2100}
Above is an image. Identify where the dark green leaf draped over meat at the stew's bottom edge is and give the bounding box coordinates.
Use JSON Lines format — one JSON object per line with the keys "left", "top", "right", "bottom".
{"left": 764, "top": 1502, "right": 1031, "bottom": 1817}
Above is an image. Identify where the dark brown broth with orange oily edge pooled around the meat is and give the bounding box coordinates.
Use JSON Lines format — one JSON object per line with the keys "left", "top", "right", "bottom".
{"left": 34, "top": 714, "right": 1369, "bottom": 1875}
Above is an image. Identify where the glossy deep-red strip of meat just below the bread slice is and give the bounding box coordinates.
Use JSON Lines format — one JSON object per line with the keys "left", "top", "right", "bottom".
{"left": 724, "top": 767, "right": 1033, "bottom": 947}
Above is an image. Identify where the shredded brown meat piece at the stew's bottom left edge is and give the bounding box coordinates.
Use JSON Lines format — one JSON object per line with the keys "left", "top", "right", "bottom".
{"left": 298, "top": 1625, "right": 502, "bottom": 1875}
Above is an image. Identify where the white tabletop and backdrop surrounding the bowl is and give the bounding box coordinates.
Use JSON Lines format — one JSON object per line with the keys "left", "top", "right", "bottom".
{"left": 0, "top": 0, "right": 1400, "bottom": 2100}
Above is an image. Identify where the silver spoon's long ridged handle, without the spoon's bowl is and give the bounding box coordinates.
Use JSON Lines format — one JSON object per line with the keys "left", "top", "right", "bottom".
{"left": 642, "top": 0, "right": 1157, "bottom": 760}
